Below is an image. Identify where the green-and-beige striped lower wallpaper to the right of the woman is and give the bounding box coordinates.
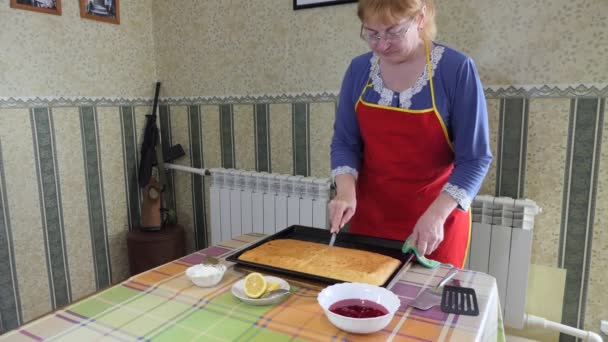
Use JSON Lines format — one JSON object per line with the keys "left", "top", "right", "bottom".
{"left": 494, "top": 98, "right": 608, "bottom": 341}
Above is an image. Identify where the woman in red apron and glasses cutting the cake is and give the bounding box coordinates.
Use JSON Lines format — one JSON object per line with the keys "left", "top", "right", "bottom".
{"left": 329, "top": 0, "right": 492, "bottom": 267}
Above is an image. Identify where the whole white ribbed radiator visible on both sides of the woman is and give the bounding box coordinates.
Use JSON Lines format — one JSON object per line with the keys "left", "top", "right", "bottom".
{"left": 210, "top": 168, "right": 539, "bottom": 328}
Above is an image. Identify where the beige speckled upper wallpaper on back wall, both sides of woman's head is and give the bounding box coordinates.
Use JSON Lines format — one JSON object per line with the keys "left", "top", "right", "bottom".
{"left": 153, "top": 0, "right": 608, "bottom": 96}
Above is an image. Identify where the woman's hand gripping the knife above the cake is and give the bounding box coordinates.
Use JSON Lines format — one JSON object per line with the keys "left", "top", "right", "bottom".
{"left": 328, "top": 174, "right": 357, "bottom": 233}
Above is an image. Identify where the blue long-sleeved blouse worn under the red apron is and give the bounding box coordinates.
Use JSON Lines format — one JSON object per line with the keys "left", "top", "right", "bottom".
{"left": 331, "top": 43, "right": 492, "bottom": 210}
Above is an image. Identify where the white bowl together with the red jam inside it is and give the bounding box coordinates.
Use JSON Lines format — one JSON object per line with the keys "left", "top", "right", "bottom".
{"left": 317, "top": 283, "right": 401, "bottom": 334}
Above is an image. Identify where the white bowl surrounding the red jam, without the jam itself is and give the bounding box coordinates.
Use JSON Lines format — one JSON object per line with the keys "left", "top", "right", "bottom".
{"left": 317, "top": 283, "right": 401, "bottom": 334}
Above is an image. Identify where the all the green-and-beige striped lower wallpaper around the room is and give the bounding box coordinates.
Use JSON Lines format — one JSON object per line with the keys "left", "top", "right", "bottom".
{"left": 0, "top": 86, "right": 608, "bottom": 341}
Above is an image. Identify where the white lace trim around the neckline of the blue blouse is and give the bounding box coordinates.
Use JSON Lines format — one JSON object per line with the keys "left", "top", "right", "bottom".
{"left": 370, "top": 45, "right": 445, "bottom": 109}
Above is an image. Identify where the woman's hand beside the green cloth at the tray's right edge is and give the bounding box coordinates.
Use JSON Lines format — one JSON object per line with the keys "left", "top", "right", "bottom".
{"left": 411, "top": 193, "right": 457, "bottom": 255}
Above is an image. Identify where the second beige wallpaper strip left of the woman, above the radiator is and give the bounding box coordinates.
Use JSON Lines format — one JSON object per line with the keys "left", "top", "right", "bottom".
{"left": 269, "top": 104, "right": 293, "bottom": 175}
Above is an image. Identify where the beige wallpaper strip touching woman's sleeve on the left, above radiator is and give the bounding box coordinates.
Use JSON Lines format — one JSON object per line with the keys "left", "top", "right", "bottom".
{"left": 310, "top": 102, "right": 336, "bottom": 177}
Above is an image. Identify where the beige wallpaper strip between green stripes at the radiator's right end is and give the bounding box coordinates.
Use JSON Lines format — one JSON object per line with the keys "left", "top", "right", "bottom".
{"left": 525, "top": 99, "right": 570, "bottom": 267}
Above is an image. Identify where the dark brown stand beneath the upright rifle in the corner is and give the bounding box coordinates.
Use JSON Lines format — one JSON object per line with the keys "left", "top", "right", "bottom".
{"left": 127, "top": 225, "right": 186, "bottom": 275}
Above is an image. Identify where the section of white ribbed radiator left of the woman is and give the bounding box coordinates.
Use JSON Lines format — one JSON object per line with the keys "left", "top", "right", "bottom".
{"left": 209, "top": 168, "right": 330, "bottom": 245}
